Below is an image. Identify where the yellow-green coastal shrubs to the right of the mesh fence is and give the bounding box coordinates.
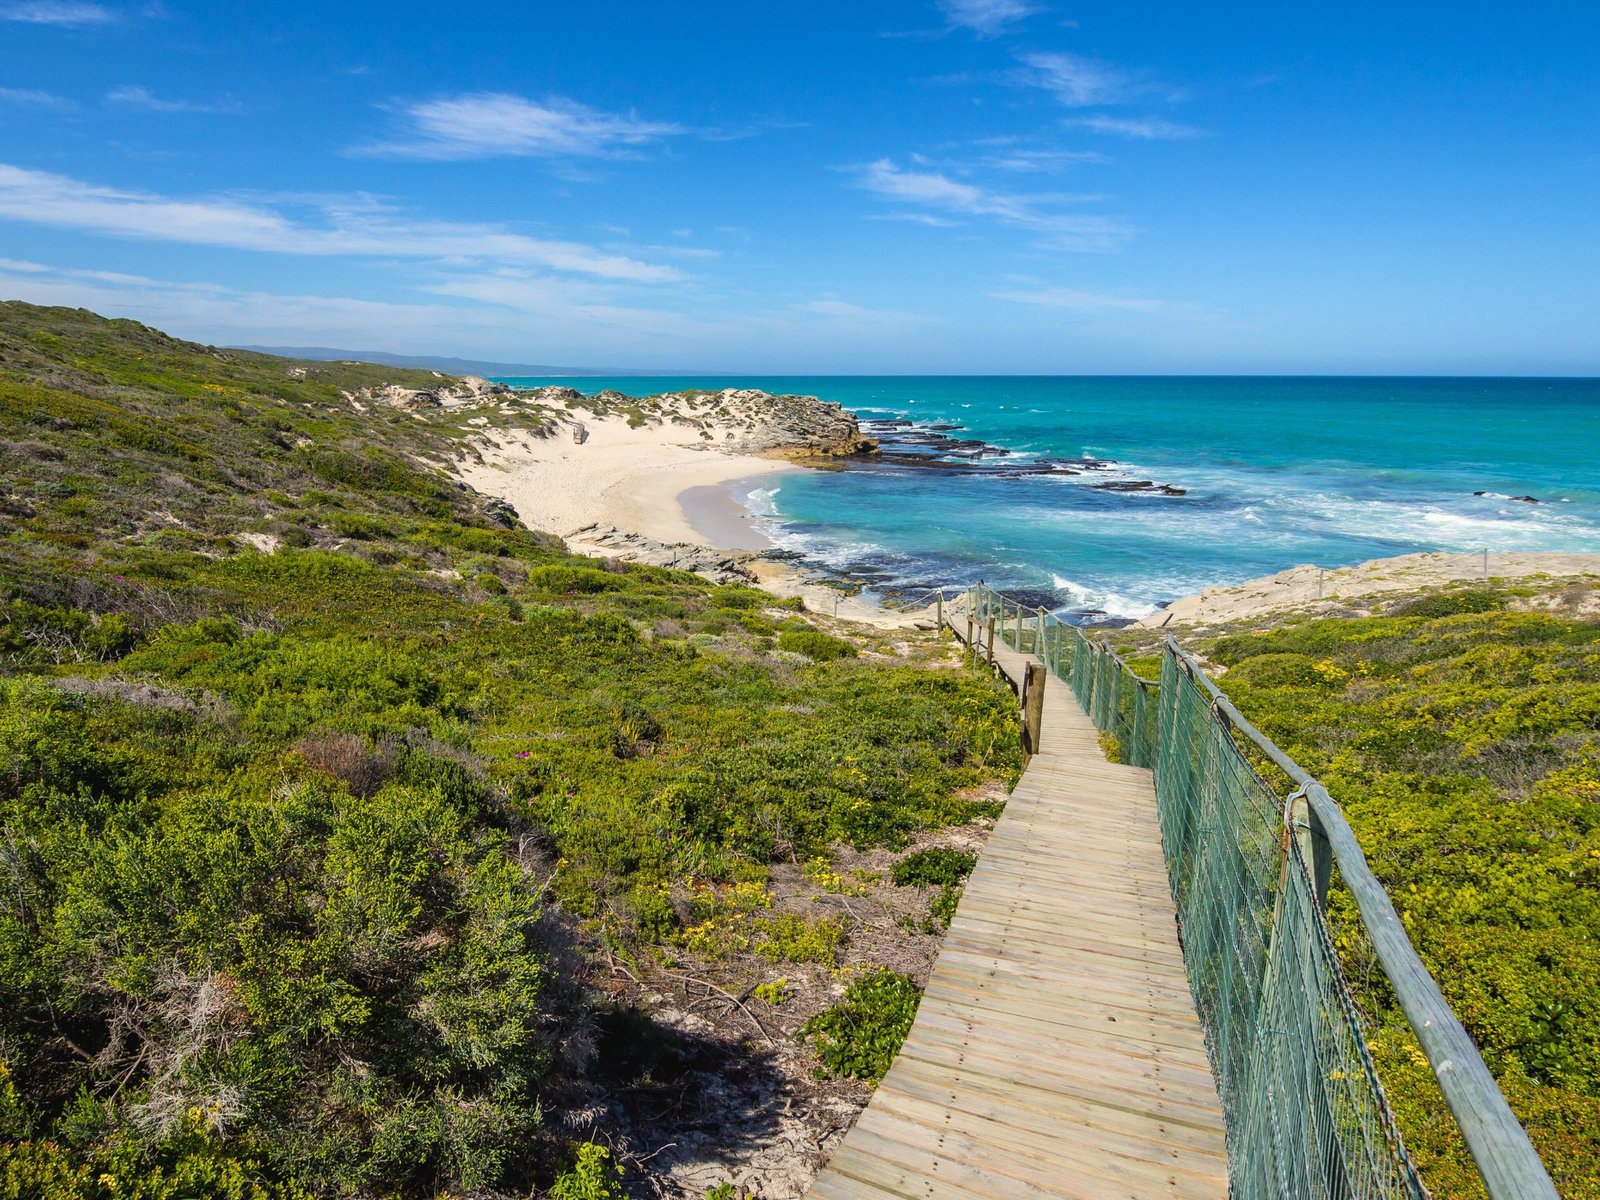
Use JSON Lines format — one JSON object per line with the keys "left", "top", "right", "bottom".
{"left": 1200, "top": 592, "right": 1600, "bottom": 1200}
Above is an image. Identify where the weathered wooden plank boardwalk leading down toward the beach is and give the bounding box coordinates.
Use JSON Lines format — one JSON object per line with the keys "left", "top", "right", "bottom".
{"left": 808, "top": 633, "right": 1227, "bottom": 1200}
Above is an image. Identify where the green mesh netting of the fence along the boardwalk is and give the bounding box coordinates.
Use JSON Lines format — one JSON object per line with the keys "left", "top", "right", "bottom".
{"left": 968, "top": 589, "right": 1427, "bottom": 1200}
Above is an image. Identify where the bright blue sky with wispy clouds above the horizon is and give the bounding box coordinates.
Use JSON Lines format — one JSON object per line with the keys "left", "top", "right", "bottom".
{"left": 0, "top": 0, "right": 1600, "bottom": 374}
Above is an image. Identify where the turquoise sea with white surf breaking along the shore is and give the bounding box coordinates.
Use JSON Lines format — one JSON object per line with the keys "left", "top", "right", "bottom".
{"left": 506, "top": 376, "right": 1600, "bottom": 618}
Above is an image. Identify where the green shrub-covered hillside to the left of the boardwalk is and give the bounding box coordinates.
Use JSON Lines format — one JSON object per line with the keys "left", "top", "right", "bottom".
{"left": 0, "top": 304, "right": 1018, "bottom": 1198}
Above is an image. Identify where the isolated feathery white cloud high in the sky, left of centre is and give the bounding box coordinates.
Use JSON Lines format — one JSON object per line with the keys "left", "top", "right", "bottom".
{"left": 355, "top": 91, "right": 683, "bottom": 160}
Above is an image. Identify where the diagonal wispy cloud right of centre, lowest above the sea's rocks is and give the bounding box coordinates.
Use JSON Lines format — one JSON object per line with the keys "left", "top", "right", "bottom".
{"left": 856, "top": 158, "right": 1133, "bottom": 250}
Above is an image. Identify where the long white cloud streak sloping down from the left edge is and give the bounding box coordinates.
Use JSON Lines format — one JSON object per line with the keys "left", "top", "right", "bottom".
{"left": 0, "top": 163, "right": 682, "bottom": 283}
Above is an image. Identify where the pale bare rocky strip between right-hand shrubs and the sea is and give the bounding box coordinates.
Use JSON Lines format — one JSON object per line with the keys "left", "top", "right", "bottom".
{"left": 1136, "top": 552, "right": 1600, "bottom": 629}
